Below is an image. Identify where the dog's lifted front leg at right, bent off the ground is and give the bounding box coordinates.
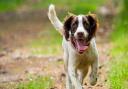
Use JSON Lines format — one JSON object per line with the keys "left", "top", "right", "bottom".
{"left": 90, "top": 58, "right": 98, "bottom": 85}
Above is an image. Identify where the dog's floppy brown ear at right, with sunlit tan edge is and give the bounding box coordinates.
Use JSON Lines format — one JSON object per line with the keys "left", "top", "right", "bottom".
{"left": 87, "top": 14, "right": 99, "bottom": 39}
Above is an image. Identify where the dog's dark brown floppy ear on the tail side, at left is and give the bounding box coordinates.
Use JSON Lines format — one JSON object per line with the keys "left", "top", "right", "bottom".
{"left": 64, "top": 15, "right": 74, "bottom": 40}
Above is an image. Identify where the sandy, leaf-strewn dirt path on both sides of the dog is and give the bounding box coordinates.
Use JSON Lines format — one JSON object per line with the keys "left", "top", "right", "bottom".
{"left": 0, "top": 44, "right": 109, "bottom": 89}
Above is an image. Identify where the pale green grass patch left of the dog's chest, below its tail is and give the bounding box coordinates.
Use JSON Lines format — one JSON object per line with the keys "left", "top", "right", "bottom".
{"left": 28, "top": 28, "right": 62, "bottom": 55}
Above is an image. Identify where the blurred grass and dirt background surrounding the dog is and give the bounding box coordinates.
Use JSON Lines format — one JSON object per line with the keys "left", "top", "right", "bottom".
{"left": 0, "top": 0, "right": 128, "bottom": 89}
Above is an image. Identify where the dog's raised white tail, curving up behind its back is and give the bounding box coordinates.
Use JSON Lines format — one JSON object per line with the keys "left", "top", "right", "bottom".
{"left": 48, "top": 4, "right": 63, "bottom": 35}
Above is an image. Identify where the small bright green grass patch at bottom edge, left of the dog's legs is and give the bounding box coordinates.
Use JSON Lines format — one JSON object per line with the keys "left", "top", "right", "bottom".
{"left": 16, "top": 76, "right": 53, "bottom": 89}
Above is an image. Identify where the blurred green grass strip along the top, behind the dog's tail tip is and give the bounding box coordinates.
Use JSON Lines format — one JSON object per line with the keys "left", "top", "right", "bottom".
{"left": 0, "top": 0, "right": 105, "bottom": 14}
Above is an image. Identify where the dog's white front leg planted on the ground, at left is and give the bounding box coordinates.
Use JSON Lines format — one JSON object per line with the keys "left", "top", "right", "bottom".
{"left": 68, "top": 65, "right": 83, "bottom": 89}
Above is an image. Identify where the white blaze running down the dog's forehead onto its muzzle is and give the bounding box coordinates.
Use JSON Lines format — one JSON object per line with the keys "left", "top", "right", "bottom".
{"left": 74, "top": 15, "right": 88, "bottom": 38}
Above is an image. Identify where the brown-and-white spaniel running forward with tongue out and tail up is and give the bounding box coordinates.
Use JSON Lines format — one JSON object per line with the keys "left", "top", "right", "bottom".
{"left": 48, "top": 4, "right": 98, "bottom": 89}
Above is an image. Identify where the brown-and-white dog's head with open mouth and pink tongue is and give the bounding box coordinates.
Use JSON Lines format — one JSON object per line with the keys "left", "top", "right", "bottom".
{"left": 64, "top": 14, "right": 98, "bottom": 53}
